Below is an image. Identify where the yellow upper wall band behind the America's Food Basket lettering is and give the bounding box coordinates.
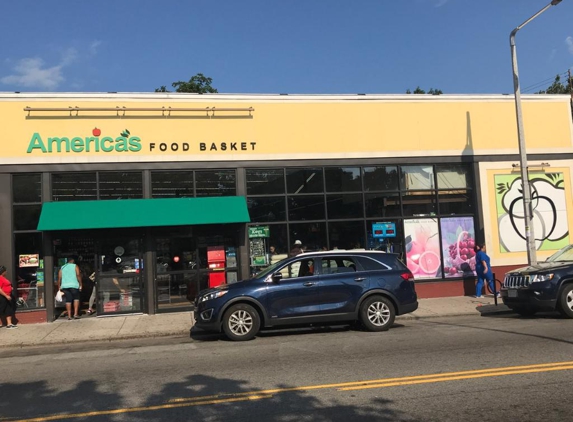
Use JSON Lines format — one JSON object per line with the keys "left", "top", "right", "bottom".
{"left": 0, "top": 94, "right": 573, "bottom": 164}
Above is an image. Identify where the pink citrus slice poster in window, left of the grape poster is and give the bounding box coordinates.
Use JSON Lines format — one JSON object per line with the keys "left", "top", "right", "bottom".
{"left": 404, "top": 218, "right": 442, "bottom": 279}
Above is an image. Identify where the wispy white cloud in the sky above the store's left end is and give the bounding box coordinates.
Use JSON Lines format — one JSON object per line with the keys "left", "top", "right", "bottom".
{"left": 0, "top": 48, "right": 78, "bottom": 90}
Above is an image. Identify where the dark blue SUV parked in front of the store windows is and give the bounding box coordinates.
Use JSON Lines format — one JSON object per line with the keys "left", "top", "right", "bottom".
{"left": 195, "top": 251, "right": 418, "bottom": 341}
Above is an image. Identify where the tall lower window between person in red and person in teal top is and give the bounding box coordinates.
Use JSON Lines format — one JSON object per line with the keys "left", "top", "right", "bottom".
{"left": 14, "top": 233, "right": 45, "bottom": 309}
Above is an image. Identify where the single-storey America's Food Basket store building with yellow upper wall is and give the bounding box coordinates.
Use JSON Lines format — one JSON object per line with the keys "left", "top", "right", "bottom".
{"left": 0, "top": 93, "right": 573, "bottom": 322}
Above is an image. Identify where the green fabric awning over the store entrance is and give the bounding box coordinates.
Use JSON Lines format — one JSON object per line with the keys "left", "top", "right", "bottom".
{"left": 38, "top": 196, "right": 250, "bottom": 231}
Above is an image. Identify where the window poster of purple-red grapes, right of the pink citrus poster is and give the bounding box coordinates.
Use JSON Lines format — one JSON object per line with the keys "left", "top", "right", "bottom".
{"left": 440, "top": 217, "right": 476, "bottom": 277}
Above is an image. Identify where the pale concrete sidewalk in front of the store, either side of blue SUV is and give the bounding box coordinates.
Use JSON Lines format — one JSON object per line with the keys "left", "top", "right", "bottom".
{"left": 0, "top": 296, "right": 509, "bottom": 348}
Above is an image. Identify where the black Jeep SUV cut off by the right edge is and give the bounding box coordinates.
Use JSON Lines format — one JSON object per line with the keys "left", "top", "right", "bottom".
{"left": 501, "top": 245, "right": 573, "bottom": 318}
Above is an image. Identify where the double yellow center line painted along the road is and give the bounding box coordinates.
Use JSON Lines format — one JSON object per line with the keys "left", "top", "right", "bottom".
{"left": 13, "top": 361, "right": 573, "bottom": 422}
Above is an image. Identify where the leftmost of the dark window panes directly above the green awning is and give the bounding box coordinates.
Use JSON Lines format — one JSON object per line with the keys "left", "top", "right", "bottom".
{"left": 52, "top": 172, "right": 97, "bottom": 201}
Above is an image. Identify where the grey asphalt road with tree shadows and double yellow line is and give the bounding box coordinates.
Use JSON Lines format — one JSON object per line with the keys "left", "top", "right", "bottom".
{"left": 0, "top": 315, "right": 573, "bottom": 422}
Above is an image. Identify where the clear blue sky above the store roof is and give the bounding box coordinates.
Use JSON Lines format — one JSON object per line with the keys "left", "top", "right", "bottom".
{"left": 0, "top": 0, "right": 573, "bottom": 94}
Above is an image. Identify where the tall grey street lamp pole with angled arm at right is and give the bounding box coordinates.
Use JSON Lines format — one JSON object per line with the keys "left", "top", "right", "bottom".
{"left": 509, "top": 0, "right": 561, "bottom": 265}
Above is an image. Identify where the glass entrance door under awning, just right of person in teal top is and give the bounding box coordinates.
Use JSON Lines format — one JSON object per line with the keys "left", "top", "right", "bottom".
{"left": 96, "top": 236, "right": 144, "bottom": 316}
